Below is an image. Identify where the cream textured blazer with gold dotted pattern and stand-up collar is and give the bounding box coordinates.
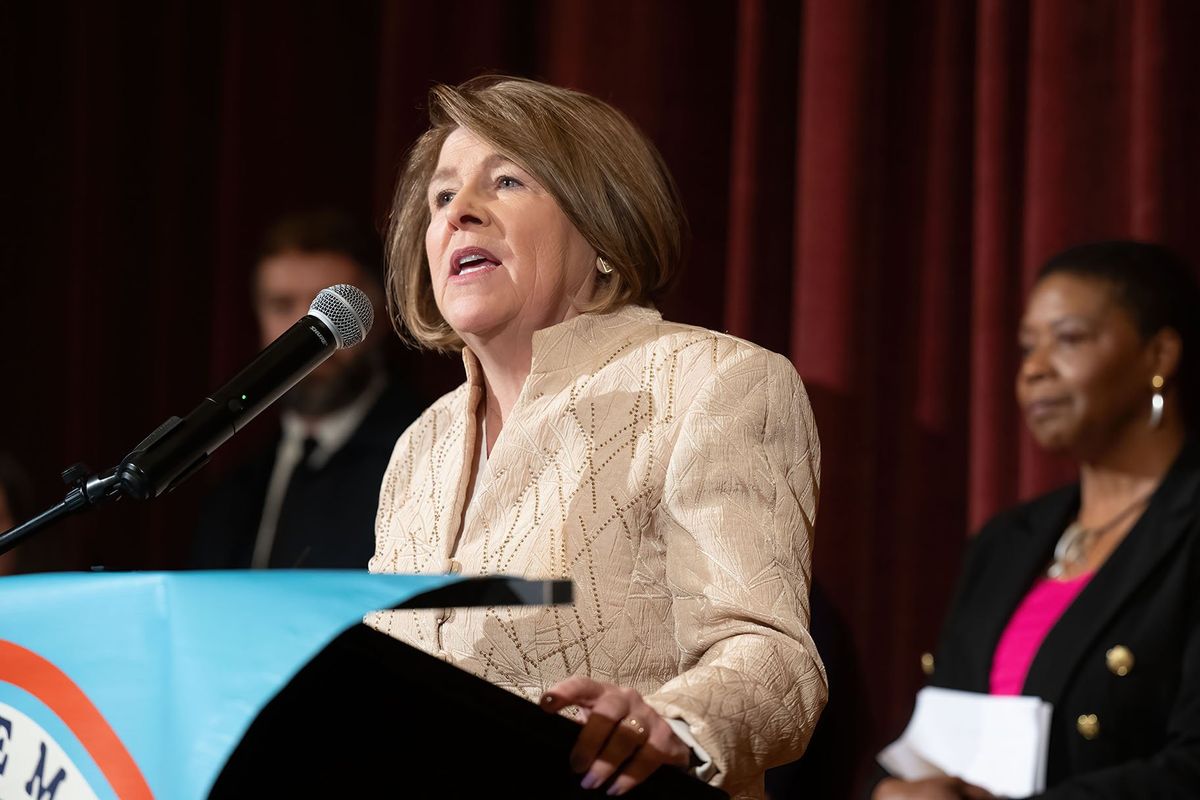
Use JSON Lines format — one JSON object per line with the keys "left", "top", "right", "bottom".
{"left": 367, "top": 306, "right": 827, "bottom": 798}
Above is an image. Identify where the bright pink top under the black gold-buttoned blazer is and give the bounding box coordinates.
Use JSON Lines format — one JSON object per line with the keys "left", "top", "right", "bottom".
{"left": 991, "top": 572, "right": 1096, "bottom": 694}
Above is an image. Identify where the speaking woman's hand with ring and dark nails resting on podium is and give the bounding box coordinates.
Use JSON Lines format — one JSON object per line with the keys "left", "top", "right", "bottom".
{"left": 541, "top": 675, "right": 691, "bottom": 794}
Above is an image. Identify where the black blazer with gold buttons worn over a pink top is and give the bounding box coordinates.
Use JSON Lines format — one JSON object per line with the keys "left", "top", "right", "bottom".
{"left": 916, "top": 444, "right": 1200, "bottom": 800}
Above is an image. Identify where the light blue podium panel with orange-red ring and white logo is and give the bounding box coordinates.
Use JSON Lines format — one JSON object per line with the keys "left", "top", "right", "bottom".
{"left": 0, "top": 570, "right": 570, "bottom": 800}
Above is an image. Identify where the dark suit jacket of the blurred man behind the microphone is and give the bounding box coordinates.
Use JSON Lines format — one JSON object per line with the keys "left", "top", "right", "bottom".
{"left": 192, "top": 379, "right": 420, "bottom": 570}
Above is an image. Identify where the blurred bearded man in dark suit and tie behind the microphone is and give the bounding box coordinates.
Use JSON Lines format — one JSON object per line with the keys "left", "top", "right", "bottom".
{"left": 193, "top": 211, "right": 420, "bottom": 569}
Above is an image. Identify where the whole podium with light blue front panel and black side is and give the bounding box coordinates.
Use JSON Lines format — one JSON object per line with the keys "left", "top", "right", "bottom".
{"left": 0, "top": 571, "right": 726, "bottom": 800}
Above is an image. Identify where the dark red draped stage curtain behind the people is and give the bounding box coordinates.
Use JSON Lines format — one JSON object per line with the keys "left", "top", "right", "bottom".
{"left": 0, "top": 0, "right": 1200, "bottom": 786}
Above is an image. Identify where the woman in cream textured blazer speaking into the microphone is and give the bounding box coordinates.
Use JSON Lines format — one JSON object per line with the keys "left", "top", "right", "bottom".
{"left": 367, "top": 77, "right": 827, "bottom": 798}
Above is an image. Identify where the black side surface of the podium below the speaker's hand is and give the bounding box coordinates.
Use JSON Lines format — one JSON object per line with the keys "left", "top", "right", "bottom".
{"left": 210, "top": 625, "right": 727, "bottom": 799}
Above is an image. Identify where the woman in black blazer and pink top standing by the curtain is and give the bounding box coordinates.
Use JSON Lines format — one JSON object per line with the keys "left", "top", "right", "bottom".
{"left": 872, "top": 242, "right": 1200, "bottom": 800}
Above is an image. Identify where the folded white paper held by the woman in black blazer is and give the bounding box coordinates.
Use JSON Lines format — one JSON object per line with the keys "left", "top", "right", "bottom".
{"left": 877, "top": 686, "right": 1052, "bottom": 798}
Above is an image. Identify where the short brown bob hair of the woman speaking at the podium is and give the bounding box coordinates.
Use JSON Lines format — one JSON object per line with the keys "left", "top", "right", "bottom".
{"left": 386, "top": 76, "right": 688, "bottom": 350}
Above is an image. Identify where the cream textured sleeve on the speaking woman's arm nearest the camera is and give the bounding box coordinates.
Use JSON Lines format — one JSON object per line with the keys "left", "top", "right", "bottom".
{"left": 647, "top": 350, "right": 828, "bottom": 792}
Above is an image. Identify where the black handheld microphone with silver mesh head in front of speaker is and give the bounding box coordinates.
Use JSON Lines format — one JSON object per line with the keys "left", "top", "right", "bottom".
{"left": 114, "top": 283, "right": 374, "bottom": 500}
